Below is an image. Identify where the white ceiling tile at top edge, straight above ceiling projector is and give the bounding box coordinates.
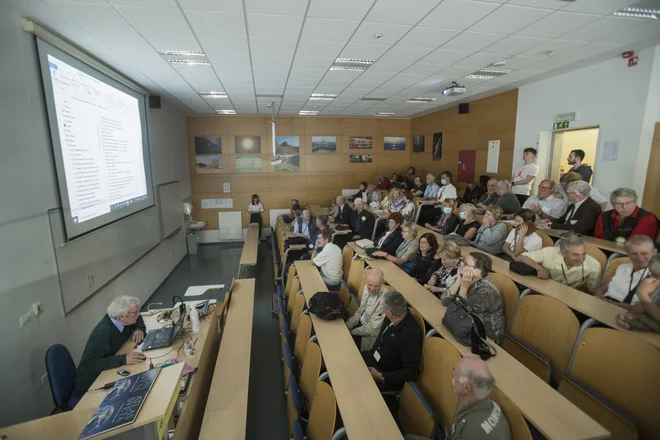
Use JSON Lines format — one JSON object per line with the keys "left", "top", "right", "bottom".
{"left": 420, "top": 0, "right": 500, "bottom": 29}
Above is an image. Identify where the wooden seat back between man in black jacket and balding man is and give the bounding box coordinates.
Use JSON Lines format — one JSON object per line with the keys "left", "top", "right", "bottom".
{"left": 417, "top": 337, "right": 461, "bottom": 426}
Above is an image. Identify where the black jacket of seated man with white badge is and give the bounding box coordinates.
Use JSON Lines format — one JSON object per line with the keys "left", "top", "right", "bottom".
{"left": 363, "top": 313, "right": 424, "bottom": 391}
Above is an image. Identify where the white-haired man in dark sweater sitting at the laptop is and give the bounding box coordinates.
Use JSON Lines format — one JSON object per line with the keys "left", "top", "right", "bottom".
{"left": 75, "top": 296, "right": 147, "bottom": 402}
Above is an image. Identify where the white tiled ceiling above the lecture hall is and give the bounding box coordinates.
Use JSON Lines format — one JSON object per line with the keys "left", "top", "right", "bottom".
{"left": 6, "top": 0, "right": 660, "bottom": 117}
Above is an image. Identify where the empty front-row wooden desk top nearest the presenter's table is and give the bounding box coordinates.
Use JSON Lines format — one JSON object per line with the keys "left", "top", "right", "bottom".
{"left": 199, "top": 278, "right": 255, "bottom": 440}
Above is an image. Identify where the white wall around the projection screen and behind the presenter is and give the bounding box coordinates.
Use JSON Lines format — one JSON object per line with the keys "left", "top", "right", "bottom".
{"left": 0, "top": 4, "right": 190, "bottom": 426}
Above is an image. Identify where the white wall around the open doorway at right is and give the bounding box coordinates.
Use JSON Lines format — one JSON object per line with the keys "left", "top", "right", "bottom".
{"left": 514, "top": 47, "right": 660, "bottom": 197}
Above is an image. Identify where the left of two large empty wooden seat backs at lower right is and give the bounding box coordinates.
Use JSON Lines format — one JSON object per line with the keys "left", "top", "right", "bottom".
{"left": 511, "top": 295, "right": 580, "bottom": 382}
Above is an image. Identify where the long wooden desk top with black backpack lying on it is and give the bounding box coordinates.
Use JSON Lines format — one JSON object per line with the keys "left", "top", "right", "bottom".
{"left": 295, "top": 261, "right": 402, "bottom": 440}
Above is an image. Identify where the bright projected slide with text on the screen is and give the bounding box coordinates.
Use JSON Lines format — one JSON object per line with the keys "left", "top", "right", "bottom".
{"left": 48, "top": 54, "right": 147, "bottom": 223}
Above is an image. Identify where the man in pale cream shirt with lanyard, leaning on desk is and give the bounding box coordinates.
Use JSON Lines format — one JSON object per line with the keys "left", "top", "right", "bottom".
{"left": 517, "top": 234, "right": 600, "bottom": 293}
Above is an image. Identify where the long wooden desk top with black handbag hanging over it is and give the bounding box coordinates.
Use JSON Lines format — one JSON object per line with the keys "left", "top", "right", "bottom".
{"left": 369, "top": 254, "right": 609, "bottom": 440}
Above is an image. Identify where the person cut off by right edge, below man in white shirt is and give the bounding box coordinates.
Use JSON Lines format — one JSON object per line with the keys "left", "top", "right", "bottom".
{"left": 616, "top": 255, "right": 660, "bottom": 333}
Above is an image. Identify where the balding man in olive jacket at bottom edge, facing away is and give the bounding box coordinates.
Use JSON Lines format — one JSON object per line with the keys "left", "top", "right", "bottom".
{"left": 404, "top": 356, "right": 512, "bottom": 440}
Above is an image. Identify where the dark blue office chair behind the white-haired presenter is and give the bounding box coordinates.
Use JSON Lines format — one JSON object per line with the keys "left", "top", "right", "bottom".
{"left": 46, "top": 344, "right": 80, "bottom": 414}
